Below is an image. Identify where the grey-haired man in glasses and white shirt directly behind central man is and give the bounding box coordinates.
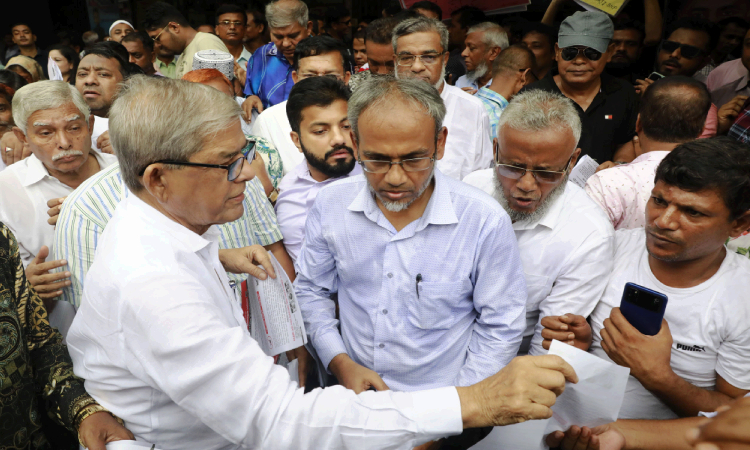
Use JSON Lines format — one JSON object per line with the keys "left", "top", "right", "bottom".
{"left": 392, "top": 17, "right": 492, "bottom": 180}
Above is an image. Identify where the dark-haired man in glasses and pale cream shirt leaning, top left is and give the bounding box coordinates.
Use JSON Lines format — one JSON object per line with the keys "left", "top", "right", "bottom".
{"left": 143, "top": 2, "right": 229, "bottom": 79}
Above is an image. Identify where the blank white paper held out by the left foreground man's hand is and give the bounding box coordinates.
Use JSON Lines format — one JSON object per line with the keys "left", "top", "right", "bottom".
{"left": 544, "top": 341, "right": 630, "bottom": 436}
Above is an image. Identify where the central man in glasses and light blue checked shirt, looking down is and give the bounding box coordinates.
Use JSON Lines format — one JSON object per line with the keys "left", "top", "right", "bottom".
{"left": 295, "top": 75, "right": 526, "bottom": 448}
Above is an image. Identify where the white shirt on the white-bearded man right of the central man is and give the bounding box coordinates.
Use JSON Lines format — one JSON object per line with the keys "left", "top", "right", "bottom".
{"left": 464, "top": 169, "right": 615, "bottom": 355}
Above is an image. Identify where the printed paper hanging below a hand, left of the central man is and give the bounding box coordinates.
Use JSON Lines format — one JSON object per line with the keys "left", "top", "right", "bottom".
{"left": 242, "top": 254, "right": 307, "bottom": 356}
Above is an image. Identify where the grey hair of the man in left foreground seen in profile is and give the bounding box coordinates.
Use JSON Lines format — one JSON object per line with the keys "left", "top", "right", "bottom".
{"left": 109, "top": 75, "right": 242, "bottom": 192}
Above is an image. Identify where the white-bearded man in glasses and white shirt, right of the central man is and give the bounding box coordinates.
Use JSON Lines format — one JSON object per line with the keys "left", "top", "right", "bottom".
{"left": 464, "top": 90, "right": 614, "bottom": 450}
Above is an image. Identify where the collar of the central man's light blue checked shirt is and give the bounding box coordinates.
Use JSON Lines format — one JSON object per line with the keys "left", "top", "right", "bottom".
{"left": 348, "top": 168, "right": 458, "bottom": 232}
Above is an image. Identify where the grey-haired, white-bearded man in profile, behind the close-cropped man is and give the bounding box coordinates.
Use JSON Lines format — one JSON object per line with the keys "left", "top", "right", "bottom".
{"left": 456, "top": 22, "right": 510, "bottom": 94}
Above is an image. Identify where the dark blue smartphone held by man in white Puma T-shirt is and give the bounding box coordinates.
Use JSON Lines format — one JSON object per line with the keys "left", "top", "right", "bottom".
{"left": 620, "top": 283, "right": 667, "bottom": 336}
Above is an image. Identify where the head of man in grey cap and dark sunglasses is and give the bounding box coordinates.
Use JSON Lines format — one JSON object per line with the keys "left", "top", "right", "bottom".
{"left": 555, "top": 11, "right": 614, "bottom": 86}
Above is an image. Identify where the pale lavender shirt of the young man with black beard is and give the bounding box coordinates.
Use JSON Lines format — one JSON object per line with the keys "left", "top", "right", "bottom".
{"left": 275, "top": 160, "right": 362, "bottom": 261}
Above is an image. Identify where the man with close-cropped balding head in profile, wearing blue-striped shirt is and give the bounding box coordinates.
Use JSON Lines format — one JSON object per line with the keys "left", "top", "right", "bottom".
{"left": 476, "top": 45, "right": 537, "bottom": 139}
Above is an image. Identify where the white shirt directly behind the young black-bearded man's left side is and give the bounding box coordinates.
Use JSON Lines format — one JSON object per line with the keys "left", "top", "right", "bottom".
{"left": 252, "top": 100, "right": 305, "bottom": 175}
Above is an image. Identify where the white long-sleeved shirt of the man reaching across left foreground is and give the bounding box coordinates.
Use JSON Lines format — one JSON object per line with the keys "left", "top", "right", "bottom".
{"left": 68, "top": 196, "right": 462, "bottom": 450}
